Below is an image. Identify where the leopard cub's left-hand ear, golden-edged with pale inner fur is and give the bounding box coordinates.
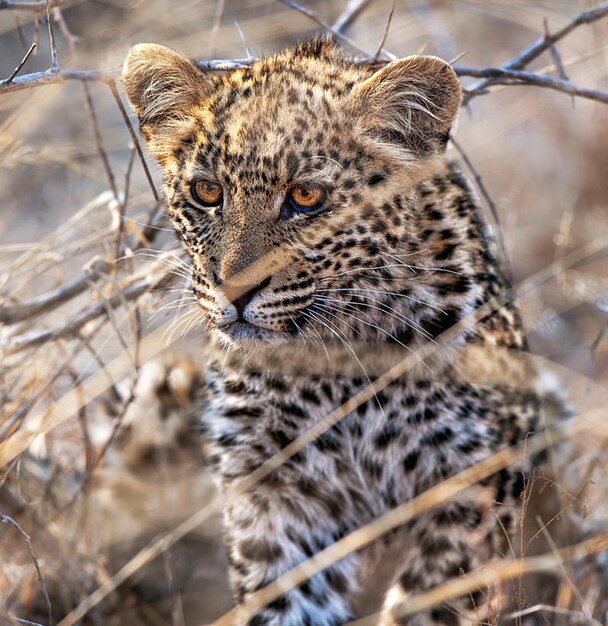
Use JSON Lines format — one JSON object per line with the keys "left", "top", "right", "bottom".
{"left": 122, "top": 43, "right": 217, "bottom": 139}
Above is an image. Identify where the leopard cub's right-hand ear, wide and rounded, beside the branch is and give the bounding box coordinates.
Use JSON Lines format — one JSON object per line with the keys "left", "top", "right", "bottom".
{"left": 353, "top": 56, "right": 462, "bottom": 157}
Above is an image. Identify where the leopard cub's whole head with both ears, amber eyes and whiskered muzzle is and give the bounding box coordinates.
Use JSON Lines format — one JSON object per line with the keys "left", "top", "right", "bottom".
{"left": 123, "top": 40, "right": 460, "bottom": 346}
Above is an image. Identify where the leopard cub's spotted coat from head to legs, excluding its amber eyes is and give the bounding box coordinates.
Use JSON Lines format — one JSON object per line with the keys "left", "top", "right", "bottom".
{"left": 123, "top": 40, "right": 539, "bottom": 626}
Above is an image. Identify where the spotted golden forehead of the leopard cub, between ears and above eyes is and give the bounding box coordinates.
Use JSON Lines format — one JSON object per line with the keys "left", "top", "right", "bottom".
{"left": 165, "top": 56, "right": 391, "bottom": 201}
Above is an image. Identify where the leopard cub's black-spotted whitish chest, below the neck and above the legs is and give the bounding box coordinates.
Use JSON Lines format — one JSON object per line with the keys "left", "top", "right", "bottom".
{"left": 203, "top": 373, "right": 533, "bottom": 510}
